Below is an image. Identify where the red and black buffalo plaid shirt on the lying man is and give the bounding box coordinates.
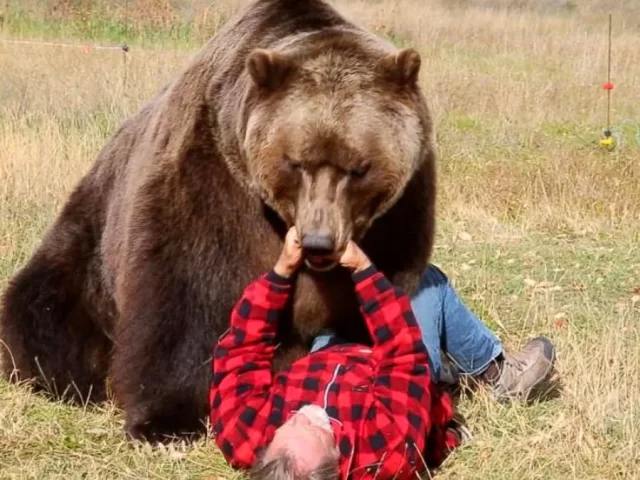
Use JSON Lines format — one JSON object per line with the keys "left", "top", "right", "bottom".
{"left": 209, "top": 266, "right": 457, "bottom": 479}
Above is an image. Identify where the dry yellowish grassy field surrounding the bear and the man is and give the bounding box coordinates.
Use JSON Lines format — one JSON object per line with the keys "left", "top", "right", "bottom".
{"left": 0, "top": 0, "right": 640, "bottom": 480}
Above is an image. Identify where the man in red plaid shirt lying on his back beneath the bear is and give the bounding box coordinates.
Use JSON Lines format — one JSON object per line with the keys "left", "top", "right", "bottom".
{"left": 210, "top": 230, "right": 555, "bottom": 479}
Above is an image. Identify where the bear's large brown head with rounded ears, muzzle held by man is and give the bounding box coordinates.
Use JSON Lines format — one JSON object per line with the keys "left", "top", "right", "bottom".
{"left": 241, "top": 32, "right": 431, "bottom": 270}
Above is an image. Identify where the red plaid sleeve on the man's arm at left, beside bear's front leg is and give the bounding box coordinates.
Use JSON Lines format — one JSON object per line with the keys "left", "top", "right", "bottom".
{"left": 209, "top": 270, "right": 291, "bottom": 469}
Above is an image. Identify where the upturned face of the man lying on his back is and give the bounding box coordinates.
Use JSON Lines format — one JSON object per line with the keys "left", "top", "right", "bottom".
{"left": 264, "top": 409, "right": 336, "bottom": 472}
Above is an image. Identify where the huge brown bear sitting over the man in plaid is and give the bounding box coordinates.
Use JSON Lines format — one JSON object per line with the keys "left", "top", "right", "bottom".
{"left": 0, "top": 0, "right": 435, "bottom": 442}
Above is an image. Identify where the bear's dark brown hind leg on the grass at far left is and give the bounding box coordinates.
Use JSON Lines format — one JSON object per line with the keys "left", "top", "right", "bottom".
{"left": 0, "top": 222, "right": 111, "bottom": 403}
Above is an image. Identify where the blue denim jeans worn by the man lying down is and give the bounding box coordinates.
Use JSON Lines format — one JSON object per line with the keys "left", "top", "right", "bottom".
{"left": 311, "top": 265, "right": 502, "bottom": 382}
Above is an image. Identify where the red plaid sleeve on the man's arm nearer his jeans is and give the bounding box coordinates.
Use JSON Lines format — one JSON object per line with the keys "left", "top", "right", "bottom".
{"left": 354, "top": 266, "right": 455, "bottom": 478}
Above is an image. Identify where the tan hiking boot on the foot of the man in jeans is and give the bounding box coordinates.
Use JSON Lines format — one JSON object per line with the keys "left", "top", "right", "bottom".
{"left": 483, "top": 337, "right": 555, "bottom": 401}
